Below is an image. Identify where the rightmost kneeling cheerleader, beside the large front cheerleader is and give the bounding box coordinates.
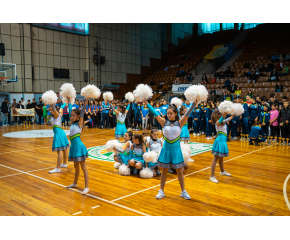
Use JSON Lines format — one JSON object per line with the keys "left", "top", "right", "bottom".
{"left": 146, "top": 129, "right": 163, "bottom": 177}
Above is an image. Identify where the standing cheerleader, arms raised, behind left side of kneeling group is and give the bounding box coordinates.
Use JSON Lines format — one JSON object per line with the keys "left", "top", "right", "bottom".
{"left": 110, "top": 103, "right": 130, "bottom": 140}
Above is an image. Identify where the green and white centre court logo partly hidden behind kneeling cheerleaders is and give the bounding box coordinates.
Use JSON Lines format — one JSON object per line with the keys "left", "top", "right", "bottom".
{"left": 88, "top": 142, "right": 212, "bottom": 162}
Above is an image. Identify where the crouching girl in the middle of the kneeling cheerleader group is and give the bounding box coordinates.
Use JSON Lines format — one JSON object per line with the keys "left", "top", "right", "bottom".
{"left": 130, "top": 134, "right": 146, "bottom": 174}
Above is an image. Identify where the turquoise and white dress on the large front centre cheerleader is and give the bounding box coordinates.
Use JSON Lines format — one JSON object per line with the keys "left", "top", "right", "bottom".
{"left": 158, "top": 121, "right": 185, "bottom": 169}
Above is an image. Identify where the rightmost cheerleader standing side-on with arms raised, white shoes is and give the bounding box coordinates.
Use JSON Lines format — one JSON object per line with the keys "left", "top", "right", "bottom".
{"left": 209, "top": 110, "right": 234, "bottom": 183}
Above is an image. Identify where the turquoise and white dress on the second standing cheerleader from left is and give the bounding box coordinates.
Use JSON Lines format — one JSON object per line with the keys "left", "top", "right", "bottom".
{"left": 68, "top": 121, "right": 88, "bottom": 162}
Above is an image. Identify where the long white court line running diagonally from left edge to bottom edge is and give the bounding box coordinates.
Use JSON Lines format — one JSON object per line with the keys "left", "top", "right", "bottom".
{"left": 0, "top": 164, "right": 150, "bottom": 216}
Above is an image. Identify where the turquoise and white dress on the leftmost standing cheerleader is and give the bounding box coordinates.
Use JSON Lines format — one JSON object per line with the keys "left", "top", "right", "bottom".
{"left": 51, "top": 113, "right": 69, "bottom": 152}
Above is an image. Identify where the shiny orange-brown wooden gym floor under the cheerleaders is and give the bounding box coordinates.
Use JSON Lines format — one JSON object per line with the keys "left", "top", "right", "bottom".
{"left": 0, "top": 125, "right": 290, "bottom": 216}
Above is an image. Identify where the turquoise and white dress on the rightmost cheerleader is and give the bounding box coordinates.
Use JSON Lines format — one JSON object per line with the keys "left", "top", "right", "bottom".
{"left": 211, "top": 118, "right": 231, "bottom": 157}
